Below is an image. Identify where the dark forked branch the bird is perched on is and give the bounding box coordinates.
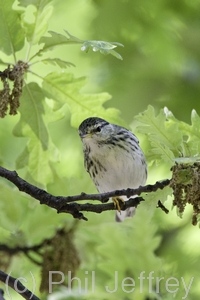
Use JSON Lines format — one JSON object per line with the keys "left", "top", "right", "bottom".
{"left": 0, "top": 167, "right": 170, "bottom": 221}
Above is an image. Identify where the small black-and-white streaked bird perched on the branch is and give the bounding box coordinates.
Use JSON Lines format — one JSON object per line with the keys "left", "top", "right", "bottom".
{"left": 78, "top": 117, "right": 147, "bottom": 222}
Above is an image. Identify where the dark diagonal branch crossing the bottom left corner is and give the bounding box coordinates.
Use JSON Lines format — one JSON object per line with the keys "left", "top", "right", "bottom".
{"left": 0, "top": 271, "right": 40, "bottom": 300}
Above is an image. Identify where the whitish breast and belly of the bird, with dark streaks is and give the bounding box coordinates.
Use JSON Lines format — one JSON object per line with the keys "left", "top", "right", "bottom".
{"left": 85, "top": 139, "right": 146, "bottom": 193}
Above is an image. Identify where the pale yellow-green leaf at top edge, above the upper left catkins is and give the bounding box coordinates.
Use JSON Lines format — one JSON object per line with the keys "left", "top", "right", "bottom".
{"left": 20, "top": 0, "right": 53, "bottom": 45}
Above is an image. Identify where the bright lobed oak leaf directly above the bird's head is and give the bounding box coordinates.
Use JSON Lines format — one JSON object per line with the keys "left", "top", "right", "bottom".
{"left": 43, "top": 72, "right": 120, "bottom": 127}
